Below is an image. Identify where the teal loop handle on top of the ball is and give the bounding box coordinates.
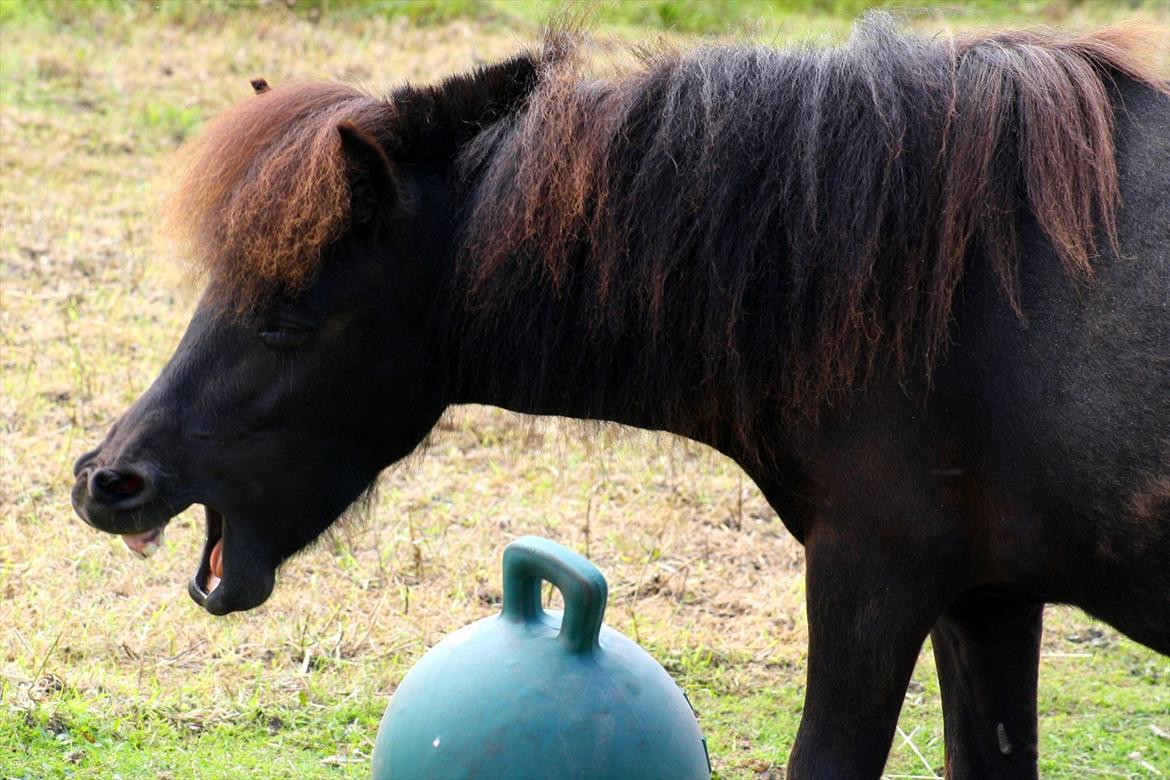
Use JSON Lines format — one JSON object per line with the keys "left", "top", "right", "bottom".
{"left": 503, "top": 537, "right": 608, "bottom": 654}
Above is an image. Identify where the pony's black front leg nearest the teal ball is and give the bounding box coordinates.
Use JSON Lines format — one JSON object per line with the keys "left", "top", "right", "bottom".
{"left": 787, "top": 523, "right": 945, "bottom": 780}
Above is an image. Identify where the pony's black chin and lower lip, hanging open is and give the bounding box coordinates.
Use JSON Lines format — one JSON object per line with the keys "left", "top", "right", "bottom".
{"left": 187, "top": 506, "right": 276, "bottom": 615}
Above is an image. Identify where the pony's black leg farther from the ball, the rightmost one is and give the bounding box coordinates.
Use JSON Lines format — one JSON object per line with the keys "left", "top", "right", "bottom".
{"left": 930, "top": 594, "right": 1044, "bottom": 780}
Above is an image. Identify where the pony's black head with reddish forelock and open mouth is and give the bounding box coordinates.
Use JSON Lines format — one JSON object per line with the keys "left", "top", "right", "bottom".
{"left": 73, "top": 58, "right": 536, "bottom": 614}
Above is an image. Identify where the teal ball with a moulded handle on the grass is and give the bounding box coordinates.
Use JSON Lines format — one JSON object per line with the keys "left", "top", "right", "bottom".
{"left": 373, "top": 537, "right": 710, "bottom": 780}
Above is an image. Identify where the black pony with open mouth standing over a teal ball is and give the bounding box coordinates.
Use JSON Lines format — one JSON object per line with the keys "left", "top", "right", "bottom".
{"left": 74, "top": 18, "right": 1170, "bottom": 778}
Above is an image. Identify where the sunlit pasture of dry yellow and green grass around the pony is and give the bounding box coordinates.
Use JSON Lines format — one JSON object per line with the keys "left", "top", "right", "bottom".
{"left": 0, "top": 0, "right": 1170, "bottom": 780}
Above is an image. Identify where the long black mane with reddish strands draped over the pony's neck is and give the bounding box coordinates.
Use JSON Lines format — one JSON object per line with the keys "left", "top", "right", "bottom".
{"left": 461, "top": 15, "right": 1165, "bottom": 451}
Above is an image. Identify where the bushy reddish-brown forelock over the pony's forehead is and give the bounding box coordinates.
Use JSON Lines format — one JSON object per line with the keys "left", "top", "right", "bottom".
{"left": 164, "top": 83, "right": 390, "bottom": 309}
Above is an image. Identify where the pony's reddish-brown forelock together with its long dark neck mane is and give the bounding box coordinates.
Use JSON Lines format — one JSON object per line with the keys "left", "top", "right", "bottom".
{"left": 167, "top": 14, "right": 1166, "bottom": 449}
